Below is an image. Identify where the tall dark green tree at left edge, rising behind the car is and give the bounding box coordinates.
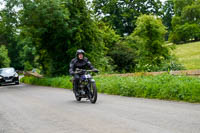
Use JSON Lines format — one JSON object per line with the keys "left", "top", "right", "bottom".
{"left": 0, "top": 0, "right": 23, "bottom": 69}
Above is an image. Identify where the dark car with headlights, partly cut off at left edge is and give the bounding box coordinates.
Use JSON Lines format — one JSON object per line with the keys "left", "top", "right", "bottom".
{"left": 0, "top": 67, "right": 19, "bottom": 85}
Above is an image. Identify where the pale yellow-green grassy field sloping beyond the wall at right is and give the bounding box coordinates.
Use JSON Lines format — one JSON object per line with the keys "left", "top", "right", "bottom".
{"left": 174, "top": 42, "right": 200, "bottom": 70}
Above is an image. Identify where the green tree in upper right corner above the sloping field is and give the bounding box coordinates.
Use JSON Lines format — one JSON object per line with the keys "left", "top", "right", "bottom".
{"left": 170, "top": 0, "right": 200, "bottom": 43}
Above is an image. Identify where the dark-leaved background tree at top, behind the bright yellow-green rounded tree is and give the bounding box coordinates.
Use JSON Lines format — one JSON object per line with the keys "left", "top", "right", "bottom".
{"left": 93, "top": 0, "right": 161, "bottom": 36}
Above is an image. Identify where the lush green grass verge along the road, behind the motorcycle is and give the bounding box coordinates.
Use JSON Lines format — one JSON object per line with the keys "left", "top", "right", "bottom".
{"left": 21, "top": 74, "right": 200, "bottom": 102}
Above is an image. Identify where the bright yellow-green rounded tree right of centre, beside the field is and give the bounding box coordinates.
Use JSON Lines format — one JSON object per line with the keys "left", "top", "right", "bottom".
{"left": 129, "top": 15, "right": 170, "bottom": 71}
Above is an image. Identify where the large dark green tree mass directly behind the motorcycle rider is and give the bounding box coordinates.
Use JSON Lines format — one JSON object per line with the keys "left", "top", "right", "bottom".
{"left": 20, "top": 0, "right": 107, "bottom": 75}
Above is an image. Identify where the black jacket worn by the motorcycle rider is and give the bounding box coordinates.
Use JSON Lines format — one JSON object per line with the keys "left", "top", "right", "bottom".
{"left": 69, "top": 57, "right": 94, "bottom": 75}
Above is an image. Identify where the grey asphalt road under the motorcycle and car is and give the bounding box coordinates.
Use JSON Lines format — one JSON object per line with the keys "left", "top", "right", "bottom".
{"left": 0, "top": 84, "right": 200, "bottom": 133}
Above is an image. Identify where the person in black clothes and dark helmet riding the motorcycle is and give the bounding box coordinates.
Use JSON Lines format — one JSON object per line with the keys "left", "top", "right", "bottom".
{"left": 69, "top": 49, "right": 97, "bottom": 96}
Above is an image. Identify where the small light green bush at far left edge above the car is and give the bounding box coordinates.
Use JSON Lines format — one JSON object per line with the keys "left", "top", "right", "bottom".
{"left": 0, "top": 45, "right": 10, "bottom": 68}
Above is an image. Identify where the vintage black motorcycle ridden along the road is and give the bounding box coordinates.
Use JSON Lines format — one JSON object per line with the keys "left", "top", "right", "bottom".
{"left": 73, "top": 69, "right": 98, "bottom": 103}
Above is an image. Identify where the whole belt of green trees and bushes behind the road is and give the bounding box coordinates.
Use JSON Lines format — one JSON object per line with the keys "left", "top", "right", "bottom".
{"left": 0, "top": 0, "right": 200, "bottom": 77}
